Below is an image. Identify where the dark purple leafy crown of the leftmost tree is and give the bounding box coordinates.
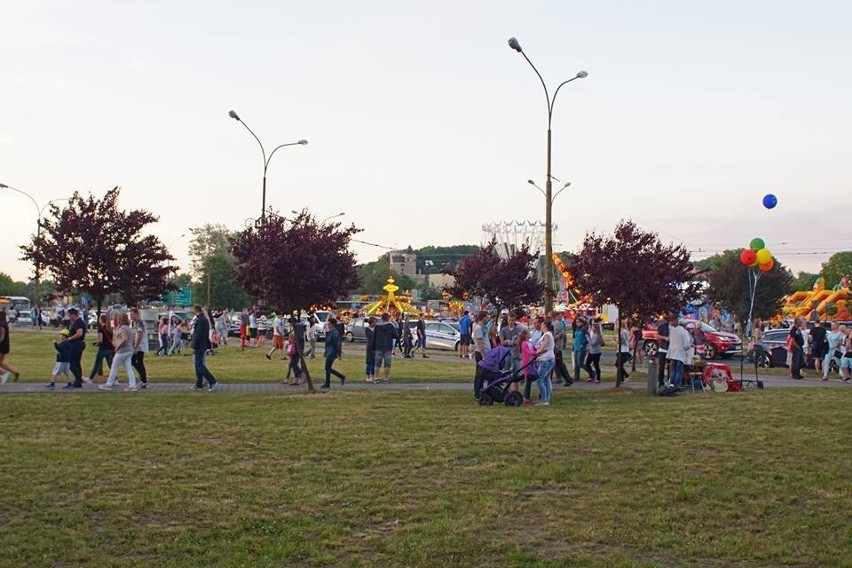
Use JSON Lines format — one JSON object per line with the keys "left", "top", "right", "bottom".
{"left": 21, "top": 187, "right": 177, "bottom": 311}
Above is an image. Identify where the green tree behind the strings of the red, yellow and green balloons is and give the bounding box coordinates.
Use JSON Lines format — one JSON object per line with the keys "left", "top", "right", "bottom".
{"left": 707, "top": 249, "right": 796, "bottom": 321}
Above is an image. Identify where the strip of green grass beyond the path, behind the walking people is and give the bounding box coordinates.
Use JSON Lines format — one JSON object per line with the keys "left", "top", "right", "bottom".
{"left": 3, "top": 329, "right": 474, "bottom": 383}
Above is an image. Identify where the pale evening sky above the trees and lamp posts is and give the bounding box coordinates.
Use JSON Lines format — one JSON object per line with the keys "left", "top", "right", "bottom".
{"left": 0, "top": 0, "right": 852, "bottom": 280}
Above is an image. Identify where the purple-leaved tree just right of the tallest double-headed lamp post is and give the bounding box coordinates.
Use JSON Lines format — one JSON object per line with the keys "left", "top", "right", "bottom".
{"left": 573, "top": 220, "right": 698, "bottom": 387}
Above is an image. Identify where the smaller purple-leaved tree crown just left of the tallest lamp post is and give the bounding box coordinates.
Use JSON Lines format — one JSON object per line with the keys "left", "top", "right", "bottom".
{"left": 442, "top": 240, "right": 544, "bottom": 308}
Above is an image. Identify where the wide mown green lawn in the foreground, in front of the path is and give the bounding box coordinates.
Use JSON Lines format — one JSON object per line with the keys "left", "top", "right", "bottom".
{"left": 0, "top": 389, "right": 852, "bottom": 567}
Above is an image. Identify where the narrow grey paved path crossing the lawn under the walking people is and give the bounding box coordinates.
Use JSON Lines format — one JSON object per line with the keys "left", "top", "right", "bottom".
{"left": 0, "top": 375, "right": 852, "bottom": 395}
